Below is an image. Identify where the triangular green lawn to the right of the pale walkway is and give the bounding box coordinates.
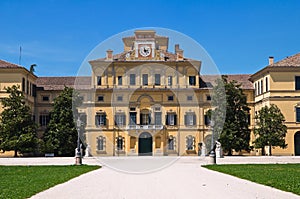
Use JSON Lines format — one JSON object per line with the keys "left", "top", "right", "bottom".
{"left": 204, "top": 164, "right": 300, "bottom": 195}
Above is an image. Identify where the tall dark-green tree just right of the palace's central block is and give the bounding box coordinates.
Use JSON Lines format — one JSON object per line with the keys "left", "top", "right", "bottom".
{"left": 212, "top": 76, "right": 250, "bottom": 155}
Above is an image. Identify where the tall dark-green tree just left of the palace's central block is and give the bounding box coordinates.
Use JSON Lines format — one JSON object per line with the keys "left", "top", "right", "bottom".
{"left": 43, "top": 87, "right": 82, "bottom": 156}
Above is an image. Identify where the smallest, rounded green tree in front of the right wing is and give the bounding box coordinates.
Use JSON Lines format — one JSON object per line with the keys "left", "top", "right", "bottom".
{"left": 253, "top": 104, "right": 287, "bottom": 155}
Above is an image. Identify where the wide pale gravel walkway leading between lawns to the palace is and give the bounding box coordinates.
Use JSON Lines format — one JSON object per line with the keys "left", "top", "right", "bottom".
{"left": 0, "top": 157, "right": 300, "bottom": 199}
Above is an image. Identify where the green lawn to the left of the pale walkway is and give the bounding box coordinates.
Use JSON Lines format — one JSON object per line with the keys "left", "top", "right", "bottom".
{"left": 0, "top": 165, "right": 100, "bottom": 199}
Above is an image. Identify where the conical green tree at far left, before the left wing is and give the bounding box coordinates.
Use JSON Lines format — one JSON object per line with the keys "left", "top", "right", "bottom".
{"left": 0, "top": 85, "right": 38, "bottom": 157}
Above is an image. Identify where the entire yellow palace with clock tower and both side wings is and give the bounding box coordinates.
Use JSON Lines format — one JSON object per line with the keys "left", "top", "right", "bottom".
{"left": 0, "top": 30, "right": 300, "bottom": 156}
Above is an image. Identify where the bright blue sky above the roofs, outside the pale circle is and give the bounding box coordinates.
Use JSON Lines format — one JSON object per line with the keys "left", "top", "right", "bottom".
{"left": 0, "top": 0, "right": 300, "bottom": 76}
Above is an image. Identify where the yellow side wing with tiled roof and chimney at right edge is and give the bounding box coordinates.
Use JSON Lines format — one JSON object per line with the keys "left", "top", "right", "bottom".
{"left": 251, "top": 53, "right": 300, "bottom": 155}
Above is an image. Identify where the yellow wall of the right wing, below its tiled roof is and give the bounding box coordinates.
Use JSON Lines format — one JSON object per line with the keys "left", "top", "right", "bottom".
{"left": 254, "top": 68, "right": 300, "bottom": 155}
